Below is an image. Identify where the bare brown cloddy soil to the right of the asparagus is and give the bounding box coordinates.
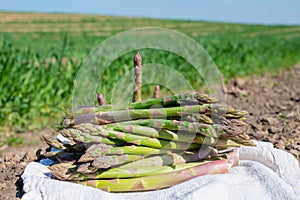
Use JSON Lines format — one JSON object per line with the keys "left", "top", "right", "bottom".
{"left": 227, "top": 66, "right": 300, "bottom": 162}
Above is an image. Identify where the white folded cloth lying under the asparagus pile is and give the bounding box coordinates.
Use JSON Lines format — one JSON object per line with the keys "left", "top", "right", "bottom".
{"left": 22, "top": 142, "right": 300, "bottom": 200}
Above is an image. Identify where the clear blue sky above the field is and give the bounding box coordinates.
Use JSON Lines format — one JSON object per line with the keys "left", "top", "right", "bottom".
{"left": 0, "top": 0, "right": 300, "bottom": 24}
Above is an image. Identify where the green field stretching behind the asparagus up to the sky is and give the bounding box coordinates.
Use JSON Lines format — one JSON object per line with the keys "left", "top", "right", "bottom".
{"left": 0, "top": 12, "right": 300, "bottom": 135}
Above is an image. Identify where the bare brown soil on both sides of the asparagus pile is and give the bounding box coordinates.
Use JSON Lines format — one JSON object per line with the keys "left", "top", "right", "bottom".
{"left": 0, "top": 66, "right": 300, "bottom": 200}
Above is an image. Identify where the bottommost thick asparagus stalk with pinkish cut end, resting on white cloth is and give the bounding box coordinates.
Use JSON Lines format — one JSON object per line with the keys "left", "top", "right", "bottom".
{"left": 80, "top": 160, "right": 232, "bottom": 192}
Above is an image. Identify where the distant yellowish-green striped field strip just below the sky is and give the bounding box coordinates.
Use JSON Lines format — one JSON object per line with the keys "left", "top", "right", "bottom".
{"left": 0, "top": 13, "right": 300, "bottom": 37}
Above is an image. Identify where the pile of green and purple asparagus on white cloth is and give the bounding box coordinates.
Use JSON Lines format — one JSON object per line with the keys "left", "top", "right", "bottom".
{"left": 43, "top": 52, "right": 254, "bottom": 192}
